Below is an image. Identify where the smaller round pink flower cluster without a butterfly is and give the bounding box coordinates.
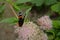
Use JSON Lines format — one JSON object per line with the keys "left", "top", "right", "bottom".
{"left": 37, "top": 15, "right": 52, "bottom": 30}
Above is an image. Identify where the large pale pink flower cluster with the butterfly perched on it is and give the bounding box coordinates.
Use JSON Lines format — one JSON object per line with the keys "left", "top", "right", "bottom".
{"left": 14, "top": 22, "right": 48, "bottom": 40}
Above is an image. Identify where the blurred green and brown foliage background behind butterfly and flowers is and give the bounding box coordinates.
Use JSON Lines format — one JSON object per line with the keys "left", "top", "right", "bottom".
{"left": 0, "top": 0, "right": 60, "bottom": 40}
